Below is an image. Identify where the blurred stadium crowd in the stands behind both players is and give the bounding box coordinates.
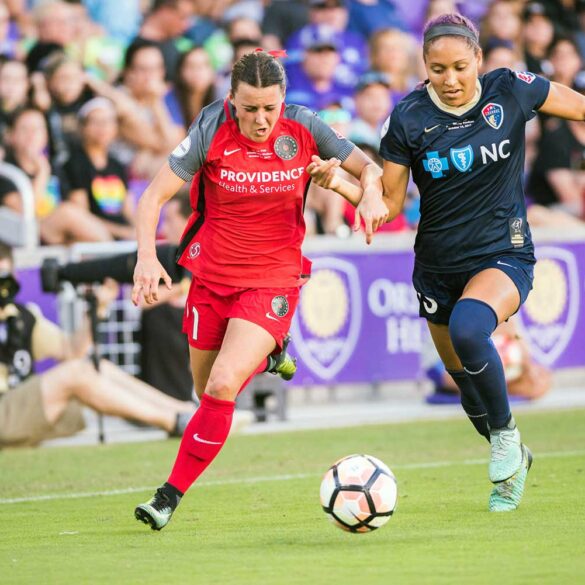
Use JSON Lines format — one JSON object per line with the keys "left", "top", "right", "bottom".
{"left": 0, "top": 0, "right": 585, "bottom": 244}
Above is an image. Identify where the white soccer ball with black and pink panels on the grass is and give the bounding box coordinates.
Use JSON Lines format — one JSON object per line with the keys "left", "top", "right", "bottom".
{"left": 320, "top": 455, "right": 398, "bottom": 532}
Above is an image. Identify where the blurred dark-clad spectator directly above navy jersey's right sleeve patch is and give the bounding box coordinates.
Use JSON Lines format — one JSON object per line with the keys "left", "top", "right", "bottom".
{"left": 522, "top": 2, "right": 555, "bottom": 75}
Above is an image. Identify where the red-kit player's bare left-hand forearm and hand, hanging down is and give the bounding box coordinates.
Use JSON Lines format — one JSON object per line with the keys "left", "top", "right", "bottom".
{"left": 132, "top": 162, "right": 185, "bottom": 305}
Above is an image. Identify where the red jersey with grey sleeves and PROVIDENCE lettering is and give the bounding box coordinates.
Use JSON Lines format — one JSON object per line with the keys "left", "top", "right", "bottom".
{"left": 169, "top": 101, "right": 354, "bottom": 288}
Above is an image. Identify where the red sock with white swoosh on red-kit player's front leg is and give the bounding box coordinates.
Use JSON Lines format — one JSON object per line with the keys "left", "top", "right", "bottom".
{"left": 168, "top": 394, "right": 236, "bottom": 493}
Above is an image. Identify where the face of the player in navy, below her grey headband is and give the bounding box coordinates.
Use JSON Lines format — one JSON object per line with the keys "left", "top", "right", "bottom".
{"left": 425, "top": 37, "right": 481, "bottom": 107}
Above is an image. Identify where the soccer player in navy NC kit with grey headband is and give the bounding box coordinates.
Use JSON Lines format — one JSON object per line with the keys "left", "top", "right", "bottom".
{"left": 308, "top": 14, "right": 585, "bottom": 511}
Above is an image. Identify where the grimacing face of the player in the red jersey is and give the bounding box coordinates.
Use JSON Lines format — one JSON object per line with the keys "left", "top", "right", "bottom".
{"left": 230, "top": 82, "right": 284, "bottom": 142}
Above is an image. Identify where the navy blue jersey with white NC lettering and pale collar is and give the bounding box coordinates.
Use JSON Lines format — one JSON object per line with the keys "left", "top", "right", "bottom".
{"left": 380, "top": 69, "right": 550, "bottom": 272}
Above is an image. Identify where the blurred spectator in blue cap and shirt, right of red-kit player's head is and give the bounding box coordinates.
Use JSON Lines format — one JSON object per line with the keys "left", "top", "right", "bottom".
{"left": 287, "top": 25, "right": 353, "bottom": 112}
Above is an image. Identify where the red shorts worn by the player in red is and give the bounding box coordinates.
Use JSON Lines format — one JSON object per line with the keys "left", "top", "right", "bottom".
{"left": 183, "top": 278, "right": 299, "bottom": 350}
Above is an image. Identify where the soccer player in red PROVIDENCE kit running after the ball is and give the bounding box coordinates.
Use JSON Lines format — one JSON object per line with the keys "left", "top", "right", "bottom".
{"left": 132, "top": 50, "right": 388, "bottom": 530}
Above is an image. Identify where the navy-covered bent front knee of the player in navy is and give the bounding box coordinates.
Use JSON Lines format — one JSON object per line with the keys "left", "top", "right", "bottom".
{"left": 449, "top": 299, "right": 498, "bottom": 356}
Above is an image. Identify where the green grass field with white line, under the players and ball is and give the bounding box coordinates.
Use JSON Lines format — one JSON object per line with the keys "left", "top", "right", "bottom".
{"left": 0, "top": 410, "right": 585, "bottom": 585}
